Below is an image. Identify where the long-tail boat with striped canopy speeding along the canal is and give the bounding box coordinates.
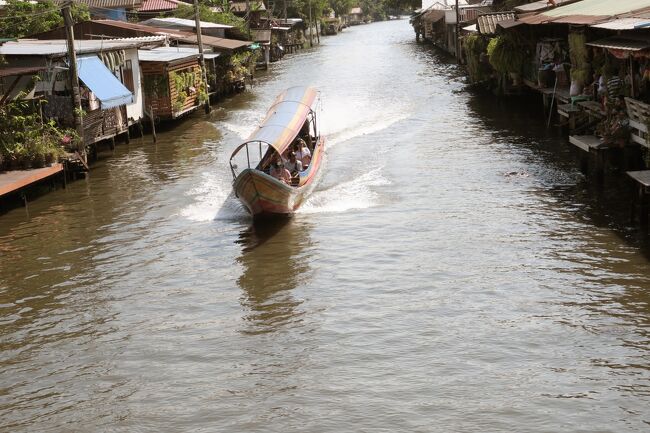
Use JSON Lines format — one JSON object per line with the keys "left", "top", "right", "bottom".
{"left": 230, "top": 87, "right": 325, "bottom": 218}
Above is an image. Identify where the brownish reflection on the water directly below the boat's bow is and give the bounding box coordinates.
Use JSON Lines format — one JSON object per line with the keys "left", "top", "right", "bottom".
{"left": 236, "top": 218, "right": 311, "bottom": 334}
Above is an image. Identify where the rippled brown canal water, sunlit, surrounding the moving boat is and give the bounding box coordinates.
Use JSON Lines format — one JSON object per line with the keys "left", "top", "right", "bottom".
{"left": 0, "top": 20, "right": 650, "bottom": 433}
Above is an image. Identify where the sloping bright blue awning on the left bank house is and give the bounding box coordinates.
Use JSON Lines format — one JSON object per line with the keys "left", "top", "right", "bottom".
{"left": 77, "top": 56, "right": 133, "bottom": 110}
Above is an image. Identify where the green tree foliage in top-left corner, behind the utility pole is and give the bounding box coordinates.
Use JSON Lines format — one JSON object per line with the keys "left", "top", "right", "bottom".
{"left": 0, "top": 0, "right": 90, "bottom": 38}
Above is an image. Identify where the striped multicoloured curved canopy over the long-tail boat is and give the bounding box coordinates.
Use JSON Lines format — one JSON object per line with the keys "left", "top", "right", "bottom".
{"left": 233, "top": 86, "right": 318, "bottom": 156}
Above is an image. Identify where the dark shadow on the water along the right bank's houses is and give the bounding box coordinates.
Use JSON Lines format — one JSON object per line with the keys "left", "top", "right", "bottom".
{"left": 468, "top": 89, "right": 650, "bottom": 258}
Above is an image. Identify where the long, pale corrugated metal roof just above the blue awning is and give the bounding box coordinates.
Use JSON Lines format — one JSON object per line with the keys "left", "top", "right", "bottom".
{"left": 0, "top": 38, "right": 146, "bottom": 57}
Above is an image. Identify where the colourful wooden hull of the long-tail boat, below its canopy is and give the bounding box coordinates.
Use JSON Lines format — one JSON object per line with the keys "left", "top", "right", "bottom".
{"left": 233, "top": 139, "right": 324, "bottom": 218}
